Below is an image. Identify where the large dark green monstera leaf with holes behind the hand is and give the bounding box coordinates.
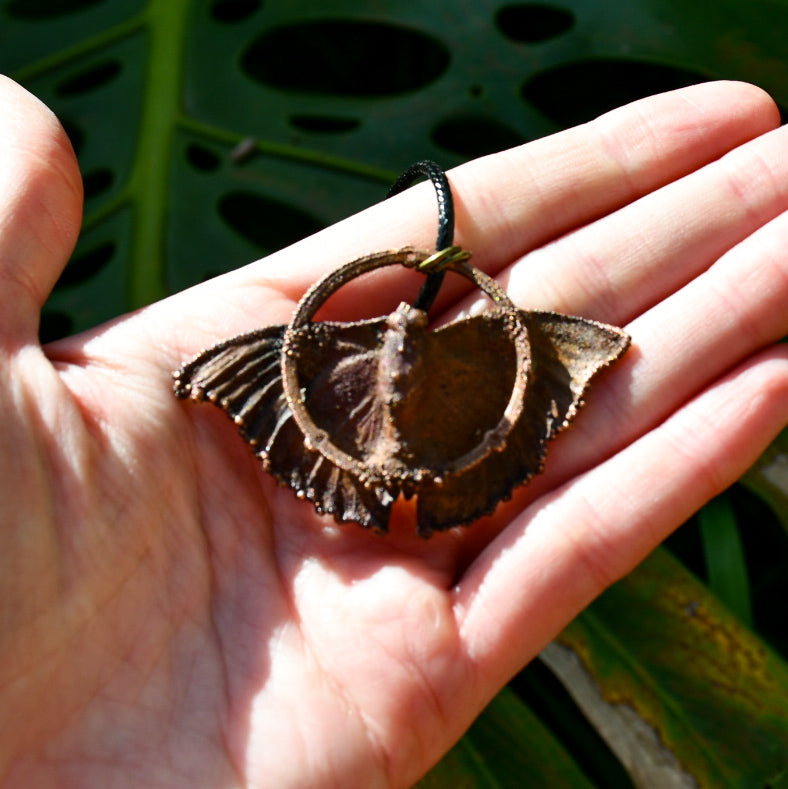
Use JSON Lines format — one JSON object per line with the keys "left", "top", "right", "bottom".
{"left": 7, "top": 0, "right": 788, "bottom": 338}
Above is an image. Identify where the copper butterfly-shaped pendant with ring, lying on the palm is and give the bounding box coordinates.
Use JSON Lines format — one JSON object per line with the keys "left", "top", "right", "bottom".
{"left": 173, "top": 162, "right": 629, "bottom": 537}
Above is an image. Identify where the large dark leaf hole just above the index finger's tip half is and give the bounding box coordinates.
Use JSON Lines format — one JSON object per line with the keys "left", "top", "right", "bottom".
{"left": 521, "top": 59, "right": 706, "bottom": 127}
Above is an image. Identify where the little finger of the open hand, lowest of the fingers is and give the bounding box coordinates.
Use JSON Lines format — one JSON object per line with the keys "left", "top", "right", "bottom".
{"left": 454, "top": 347, "right": 788, "bottom": 684}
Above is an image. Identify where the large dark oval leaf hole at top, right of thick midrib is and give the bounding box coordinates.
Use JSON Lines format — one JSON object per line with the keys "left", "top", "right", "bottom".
{"left": 241, "top": 20, "right": 449, "bottom": 96}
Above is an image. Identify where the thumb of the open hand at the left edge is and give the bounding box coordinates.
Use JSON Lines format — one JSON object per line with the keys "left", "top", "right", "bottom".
{"left": 0, "top": 76, "right": 82, "bottom": 347}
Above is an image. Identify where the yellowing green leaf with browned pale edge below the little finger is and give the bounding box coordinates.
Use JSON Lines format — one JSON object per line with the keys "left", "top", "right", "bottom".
{"left": 548, "top": 549, "right": 788, "bottom": 789}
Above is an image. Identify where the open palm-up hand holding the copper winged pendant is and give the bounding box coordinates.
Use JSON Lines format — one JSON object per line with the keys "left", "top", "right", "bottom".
{"left": 0, "top": 75, "right": 788, "bottom": 787}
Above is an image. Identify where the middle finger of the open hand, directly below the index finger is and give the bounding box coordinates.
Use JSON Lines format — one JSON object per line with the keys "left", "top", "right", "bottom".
{"left": 496, "top": 117, "right": 788, "bottom": 324}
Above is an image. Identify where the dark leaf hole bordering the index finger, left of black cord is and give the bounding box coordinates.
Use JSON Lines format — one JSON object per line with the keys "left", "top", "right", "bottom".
{"left": 219, "top": 191, "right": 323, "bottom": 253}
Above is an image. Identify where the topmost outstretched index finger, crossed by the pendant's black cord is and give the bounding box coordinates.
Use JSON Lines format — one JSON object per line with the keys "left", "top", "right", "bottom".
{"left": 160, "top": 83, "right": 779, "bottom": 350}
